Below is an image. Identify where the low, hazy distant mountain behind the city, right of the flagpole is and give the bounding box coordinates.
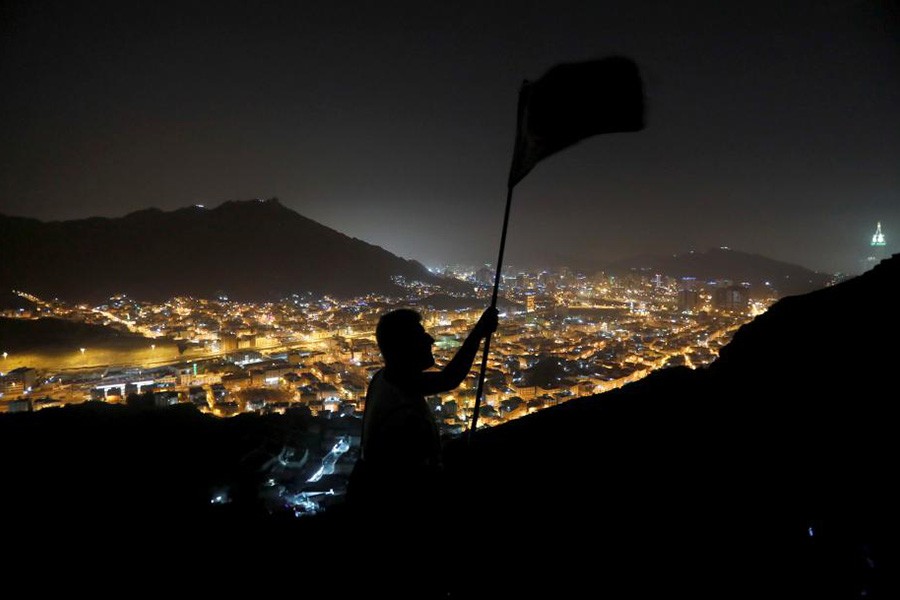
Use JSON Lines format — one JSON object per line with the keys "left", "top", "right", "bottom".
{"left": 604, "top": 248, "right": 831, "bottom": 296}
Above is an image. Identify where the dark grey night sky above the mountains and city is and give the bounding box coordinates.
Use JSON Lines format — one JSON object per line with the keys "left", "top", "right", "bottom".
{"left": 0, "top": 0, "right": 900, "bottom": 272}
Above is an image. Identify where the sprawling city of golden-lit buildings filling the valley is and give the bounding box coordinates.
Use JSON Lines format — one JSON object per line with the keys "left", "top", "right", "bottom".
{"left": 0, "top": 268, "right": 774, "bottom": 432}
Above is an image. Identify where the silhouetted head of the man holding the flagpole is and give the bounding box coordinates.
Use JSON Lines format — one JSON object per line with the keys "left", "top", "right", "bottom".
{"left": 375, "top": 308, "right": 434, "bottom": 371}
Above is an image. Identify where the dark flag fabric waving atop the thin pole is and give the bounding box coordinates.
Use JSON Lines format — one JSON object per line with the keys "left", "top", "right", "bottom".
{"left": 509, "top": 56, "right": 644, "bottom": 189}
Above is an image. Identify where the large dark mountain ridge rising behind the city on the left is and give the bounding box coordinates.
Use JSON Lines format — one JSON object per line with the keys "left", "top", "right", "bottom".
{"left": 0, "top": 199, "right": 470, "bottom": 301}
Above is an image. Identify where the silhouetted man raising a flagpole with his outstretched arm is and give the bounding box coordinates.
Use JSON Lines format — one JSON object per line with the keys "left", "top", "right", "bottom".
{"left": 348, "top": 308, "right": 497, "bottom": 526}
